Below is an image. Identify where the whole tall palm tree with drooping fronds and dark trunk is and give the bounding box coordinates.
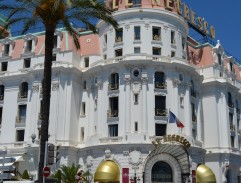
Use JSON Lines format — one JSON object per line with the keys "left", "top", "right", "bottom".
{"left": 0, "top": 0, "right": 117, "bottom": 181}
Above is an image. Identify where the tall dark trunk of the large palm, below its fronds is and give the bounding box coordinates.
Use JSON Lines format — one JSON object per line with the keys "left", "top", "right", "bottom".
{"left": 38, "top": 25, "right": 55, "bottom": 182}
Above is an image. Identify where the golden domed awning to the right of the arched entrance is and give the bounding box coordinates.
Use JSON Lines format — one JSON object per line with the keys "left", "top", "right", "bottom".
{"left": 197, "top": 165, "right": 216, "bottom": 183}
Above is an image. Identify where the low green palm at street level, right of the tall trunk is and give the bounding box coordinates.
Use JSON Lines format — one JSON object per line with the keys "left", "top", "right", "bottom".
{"left": 52, "top": 164, "right": 80, "bottom": 183}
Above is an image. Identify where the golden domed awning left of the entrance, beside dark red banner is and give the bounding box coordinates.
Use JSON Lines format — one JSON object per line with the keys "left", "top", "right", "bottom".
{"left": 94, "top": 160, "right": 120, "bottom": 182}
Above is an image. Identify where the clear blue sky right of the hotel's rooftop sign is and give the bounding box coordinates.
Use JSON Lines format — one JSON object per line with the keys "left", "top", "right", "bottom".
{"left": 185, "top": 0, "right": 241, "bottom": 61}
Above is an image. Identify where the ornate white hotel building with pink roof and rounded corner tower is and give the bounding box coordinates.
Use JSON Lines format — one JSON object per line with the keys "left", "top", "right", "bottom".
{"left": 0, "top": 0, "right": 241, "bottom": 183}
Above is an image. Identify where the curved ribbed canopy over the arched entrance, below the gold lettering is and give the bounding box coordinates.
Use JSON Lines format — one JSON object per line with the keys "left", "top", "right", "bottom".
{"left": 147, "top": 143, "right": 190, "bottom": 174}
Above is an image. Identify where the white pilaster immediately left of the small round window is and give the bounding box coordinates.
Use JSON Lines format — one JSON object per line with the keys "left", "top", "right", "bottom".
{"left": 124, "top": 74, "right": 131, "bottom": 133}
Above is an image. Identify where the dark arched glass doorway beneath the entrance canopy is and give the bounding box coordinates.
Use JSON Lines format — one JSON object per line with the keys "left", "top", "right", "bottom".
{"left": 151, "top": 161, "right": 173, "bottom": 182}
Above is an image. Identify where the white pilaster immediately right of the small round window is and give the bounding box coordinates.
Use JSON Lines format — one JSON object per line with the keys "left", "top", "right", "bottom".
{"left": 141, "top": 73, "right": 148, "bottom": 133}
